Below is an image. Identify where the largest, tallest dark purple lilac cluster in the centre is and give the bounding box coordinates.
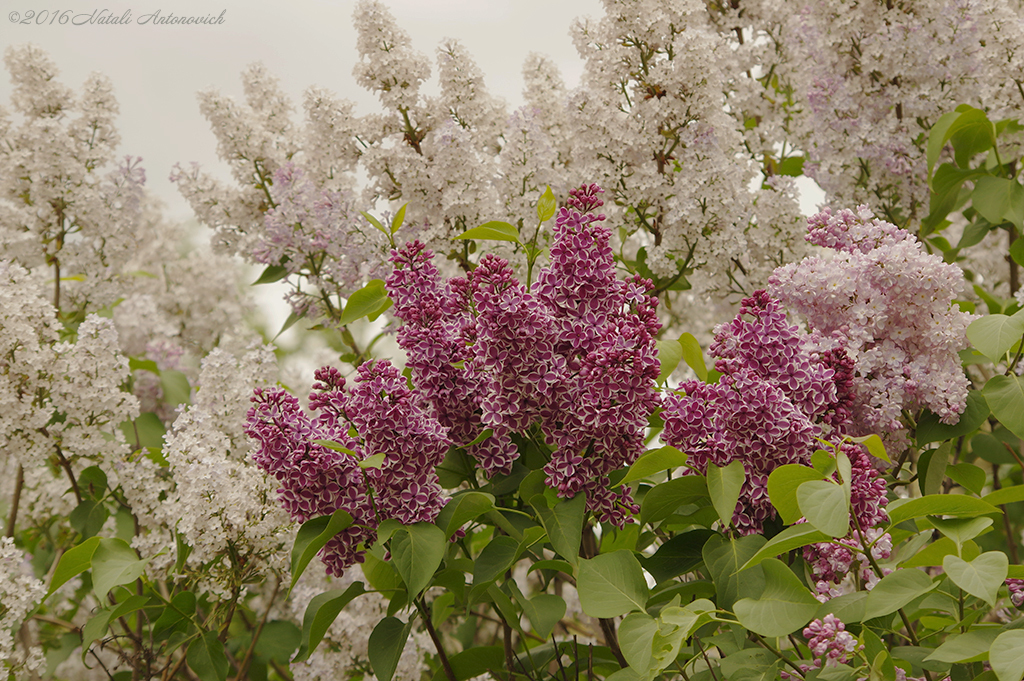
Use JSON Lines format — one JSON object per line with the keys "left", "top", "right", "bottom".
{"left": 387, "top": 184, "right": 660, "bottom": 526}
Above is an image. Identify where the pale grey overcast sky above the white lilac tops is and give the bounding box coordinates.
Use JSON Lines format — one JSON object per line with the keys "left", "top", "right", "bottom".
{"left": 0, "top": 0, "right": 603, "bottom": 218}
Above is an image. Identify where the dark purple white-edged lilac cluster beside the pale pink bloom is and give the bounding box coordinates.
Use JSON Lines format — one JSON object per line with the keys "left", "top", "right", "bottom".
{"left": 662, "top": 291, "right": 848, "bottom": 534}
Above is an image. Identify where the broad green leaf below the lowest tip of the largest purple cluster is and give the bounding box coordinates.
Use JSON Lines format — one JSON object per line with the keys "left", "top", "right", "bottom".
{"left": 577, "top": 550, "right": 648, "bottom": 618}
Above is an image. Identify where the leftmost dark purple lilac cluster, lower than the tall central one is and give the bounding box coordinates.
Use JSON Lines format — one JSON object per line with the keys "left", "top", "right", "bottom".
{"left": 246, "top": 360, "right": 449, "bottom": 576}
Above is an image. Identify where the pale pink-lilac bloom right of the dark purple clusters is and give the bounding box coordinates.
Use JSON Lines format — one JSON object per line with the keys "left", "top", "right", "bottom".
{"left": 768, "top": 206, "right": 972, "bottom": 449}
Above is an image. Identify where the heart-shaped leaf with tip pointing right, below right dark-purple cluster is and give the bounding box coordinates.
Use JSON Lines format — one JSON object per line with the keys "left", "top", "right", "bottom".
{"left": 733, "top": 558, "right": 821, "bottom": 637}
